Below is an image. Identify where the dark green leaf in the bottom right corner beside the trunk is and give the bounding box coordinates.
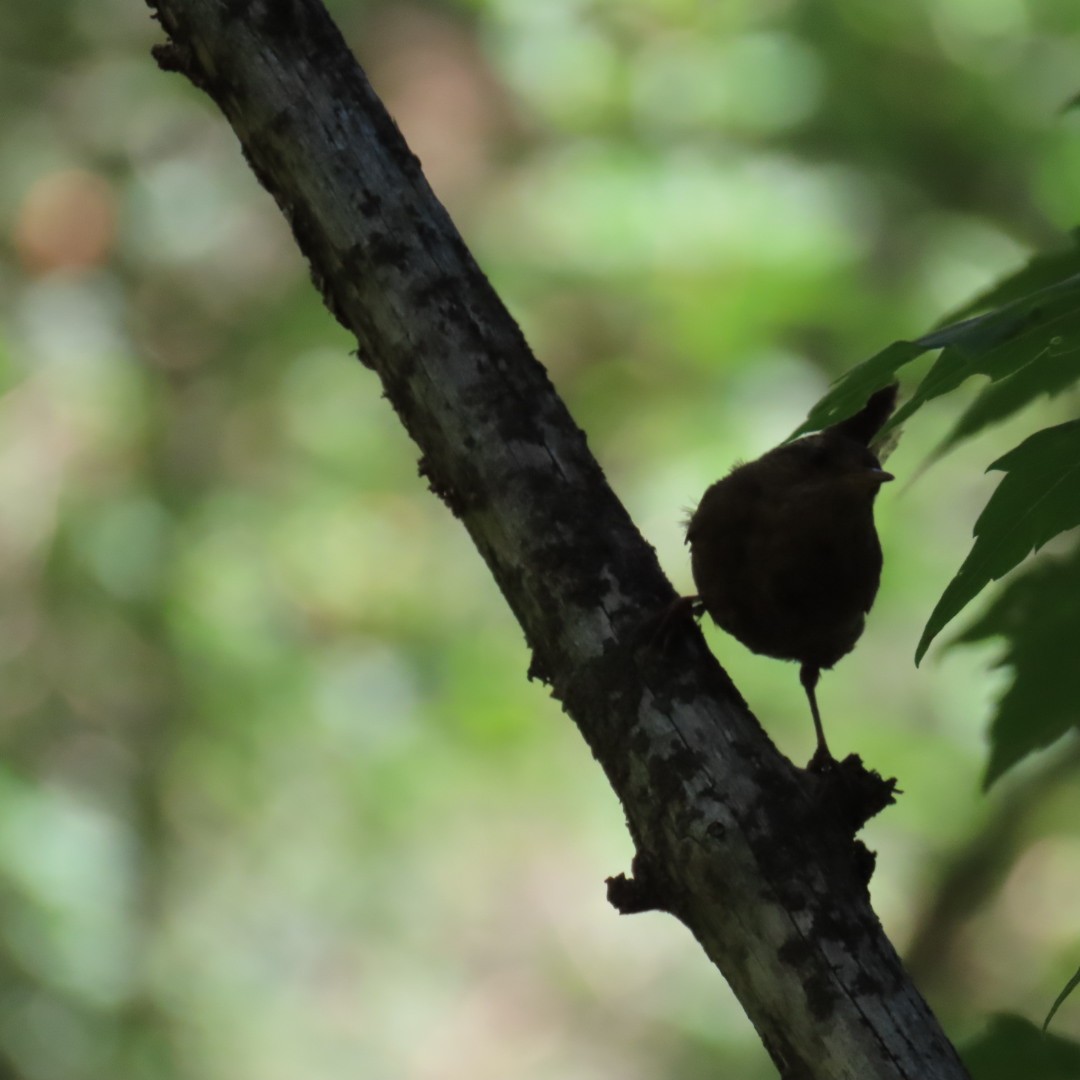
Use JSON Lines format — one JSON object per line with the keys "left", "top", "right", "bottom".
{"left": 960, "top": 1014, "right": 1080, "bottom": 1080}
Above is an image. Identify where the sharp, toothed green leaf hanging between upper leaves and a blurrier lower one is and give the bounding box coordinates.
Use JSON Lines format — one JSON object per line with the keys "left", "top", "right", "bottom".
{"left": 915, "top": 420, "right": 1080, "bottom": 663}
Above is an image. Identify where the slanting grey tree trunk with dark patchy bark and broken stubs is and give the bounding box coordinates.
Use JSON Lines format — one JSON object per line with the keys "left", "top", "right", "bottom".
{"left": 150, "top": 0, "right": 967, "bottom": 1080}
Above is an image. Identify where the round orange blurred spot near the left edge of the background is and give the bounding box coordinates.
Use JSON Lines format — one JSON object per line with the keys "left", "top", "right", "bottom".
{"left": 14, "top": 168, "right": 116, "bottom": 274}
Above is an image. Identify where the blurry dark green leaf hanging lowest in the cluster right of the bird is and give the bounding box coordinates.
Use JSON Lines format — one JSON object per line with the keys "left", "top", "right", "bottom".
{"left": 950, "top": 549, "right": 1080, "bottom": 787}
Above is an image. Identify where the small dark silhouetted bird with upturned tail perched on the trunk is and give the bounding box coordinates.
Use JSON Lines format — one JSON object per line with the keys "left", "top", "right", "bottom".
{"left": 686, "top": 383, "right": 897, "bottom": 769}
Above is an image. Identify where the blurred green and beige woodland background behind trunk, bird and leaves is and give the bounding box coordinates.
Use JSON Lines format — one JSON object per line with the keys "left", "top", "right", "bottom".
{"left": 6, "top": 0, "right": 1080, "bottom": 1080}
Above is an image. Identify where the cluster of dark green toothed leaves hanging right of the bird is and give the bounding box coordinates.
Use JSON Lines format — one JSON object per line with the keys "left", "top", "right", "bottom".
{"left": 799, "top": 232, "right": 1080, "bottom": 786}
